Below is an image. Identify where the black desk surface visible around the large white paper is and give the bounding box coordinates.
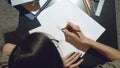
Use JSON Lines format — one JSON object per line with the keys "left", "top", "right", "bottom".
{"left": 15, "top": 0, "right": 118, "bottom": 68}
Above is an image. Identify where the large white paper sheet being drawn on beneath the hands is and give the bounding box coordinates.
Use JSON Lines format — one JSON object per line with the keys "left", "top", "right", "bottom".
{"left": 30, "top": 0, "right": 105, "bottom": 56}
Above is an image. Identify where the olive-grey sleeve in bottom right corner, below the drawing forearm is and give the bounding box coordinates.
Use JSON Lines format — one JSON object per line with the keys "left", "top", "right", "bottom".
{"left": 95, "top": 60, "right": 120, "bottom": 68}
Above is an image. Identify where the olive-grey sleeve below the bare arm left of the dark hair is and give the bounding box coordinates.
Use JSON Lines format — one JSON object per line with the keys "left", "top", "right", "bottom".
{"left": 0, "top": 52, "right": 10, "bottom": 68}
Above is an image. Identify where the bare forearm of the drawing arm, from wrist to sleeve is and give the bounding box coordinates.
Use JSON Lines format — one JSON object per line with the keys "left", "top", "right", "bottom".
{"left": 86, "top": 39, "right": 120, "bottom": 61}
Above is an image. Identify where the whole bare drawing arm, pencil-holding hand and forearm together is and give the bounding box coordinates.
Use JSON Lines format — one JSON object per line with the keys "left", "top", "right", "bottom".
{"left": 63, "top": 23, "right": 120, "bottom": 61}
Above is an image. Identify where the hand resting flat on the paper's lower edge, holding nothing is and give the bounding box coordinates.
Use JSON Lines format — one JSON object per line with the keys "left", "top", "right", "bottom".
{"left": 62, "top": 52, "right": 84, "bottom": 68}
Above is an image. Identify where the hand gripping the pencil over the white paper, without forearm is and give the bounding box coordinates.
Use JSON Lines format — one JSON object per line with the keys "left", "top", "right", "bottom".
{"left": 62, "top": 22, "right": 88, "bottom": 50}
